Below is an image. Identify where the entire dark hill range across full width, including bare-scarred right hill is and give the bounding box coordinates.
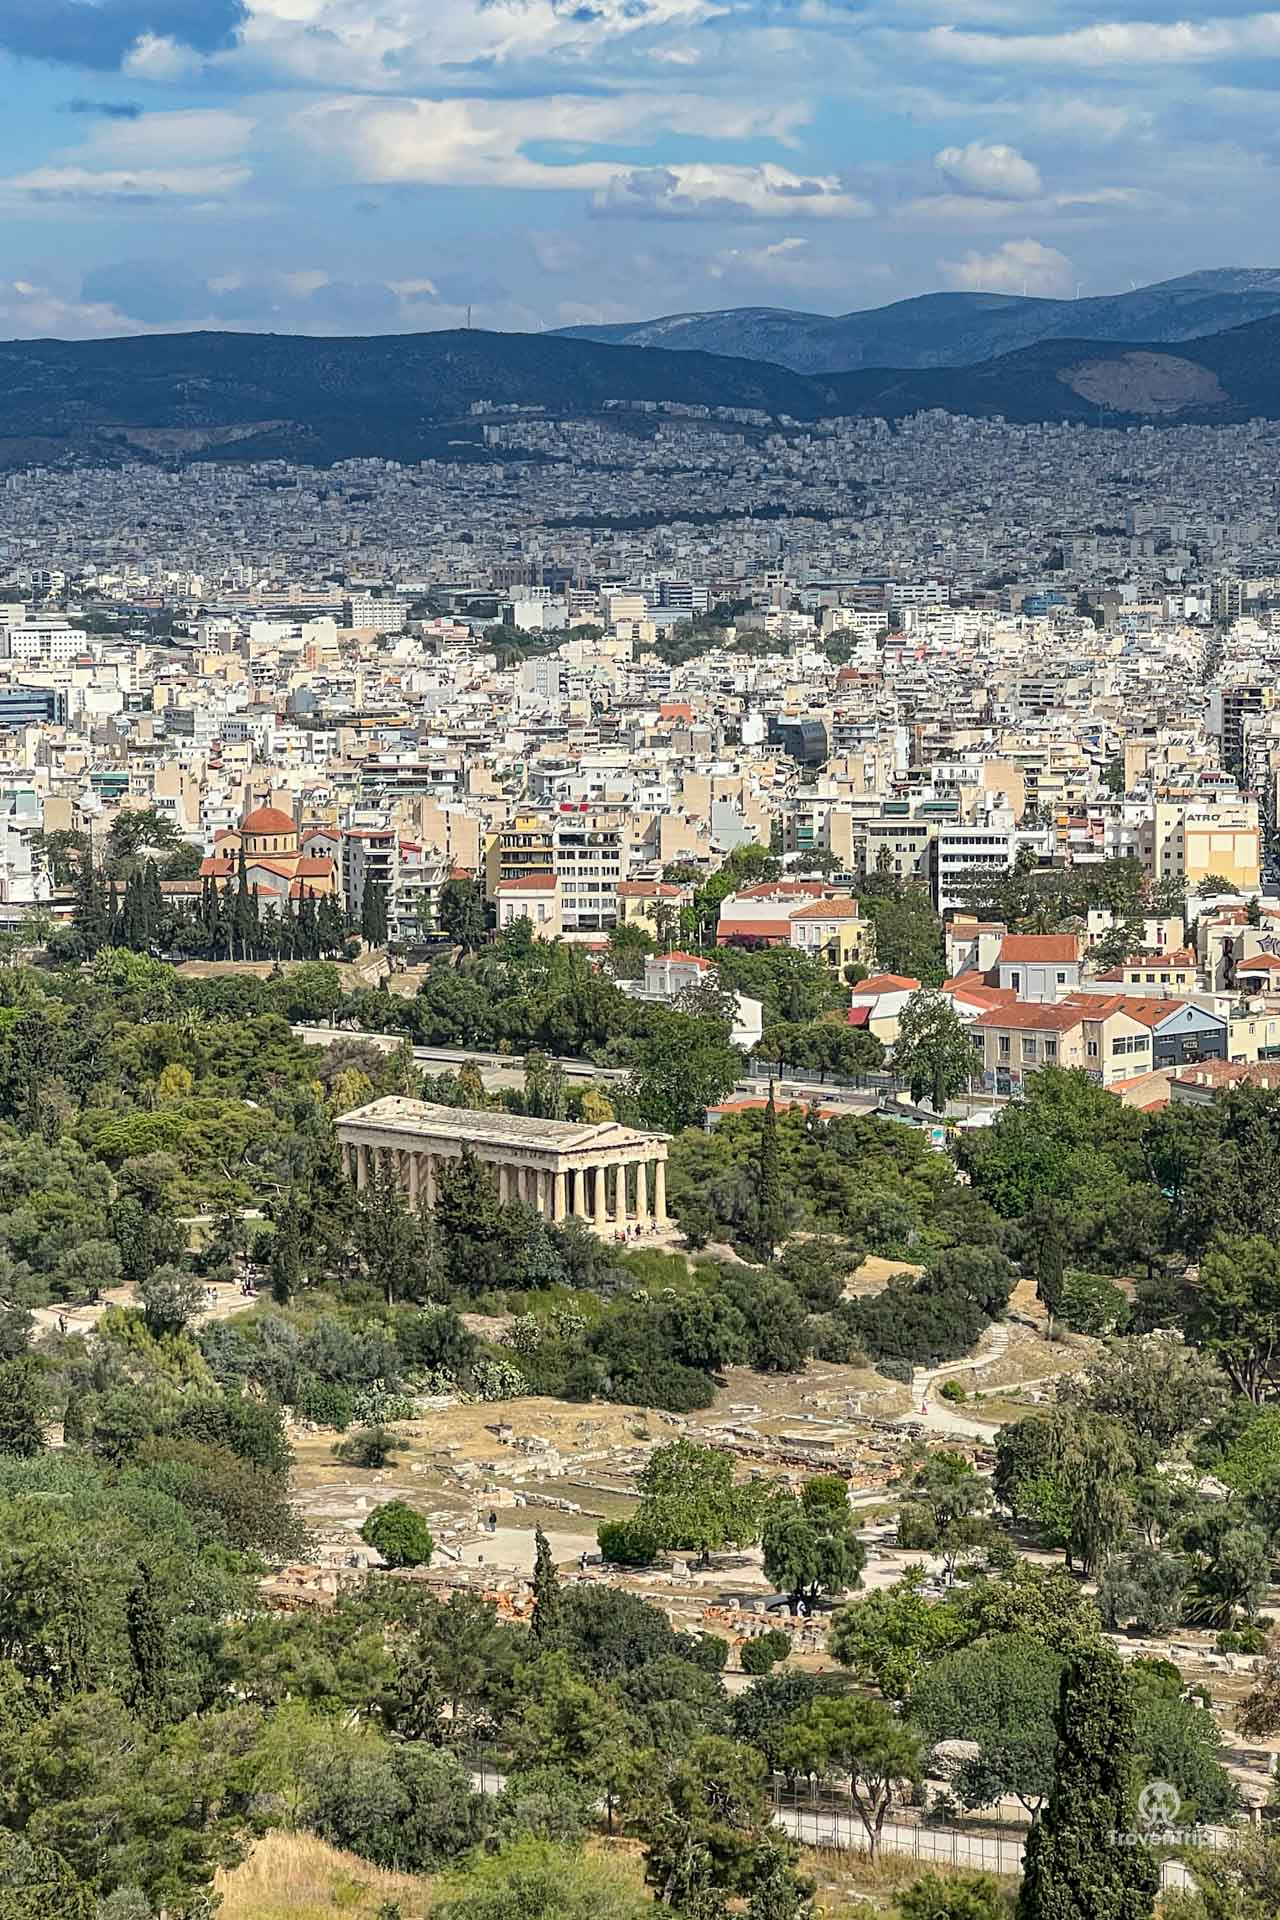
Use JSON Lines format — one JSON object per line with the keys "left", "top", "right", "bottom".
{"left": 0, "top": 315, "right": 1280, "bottom": 467}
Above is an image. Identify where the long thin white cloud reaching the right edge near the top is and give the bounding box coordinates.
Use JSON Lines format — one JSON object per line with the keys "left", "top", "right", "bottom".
{"left": 917, "top": 13, "right": 1280, "bottom": 69}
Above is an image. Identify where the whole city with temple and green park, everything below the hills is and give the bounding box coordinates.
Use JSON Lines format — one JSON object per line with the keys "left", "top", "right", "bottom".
{"left": 0, "top": 366, "right": 1280, "bottom": 1920}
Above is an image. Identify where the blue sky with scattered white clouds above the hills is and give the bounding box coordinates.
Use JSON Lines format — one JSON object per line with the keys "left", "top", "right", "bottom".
{"left": 0, "top": 0, "right": 1280, "bottom": 338}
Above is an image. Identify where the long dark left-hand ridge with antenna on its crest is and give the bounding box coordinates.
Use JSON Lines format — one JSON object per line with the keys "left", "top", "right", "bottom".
{"left": 0, "top": 330, "right": 833, "bottom": 467}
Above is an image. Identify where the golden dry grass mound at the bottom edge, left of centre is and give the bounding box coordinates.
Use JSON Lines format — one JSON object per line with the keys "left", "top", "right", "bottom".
{"left": 215, "top": 1832, "right": 428, "bottom": 1920}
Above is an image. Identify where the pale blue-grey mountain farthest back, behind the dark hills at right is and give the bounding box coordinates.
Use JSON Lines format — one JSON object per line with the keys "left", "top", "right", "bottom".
{"left": 560, "top": 267, "right": 1280, "bottom": 372}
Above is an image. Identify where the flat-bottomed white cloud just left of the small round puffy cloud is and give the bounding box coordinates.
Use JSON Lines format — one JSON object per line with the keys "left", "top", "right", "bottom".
{"left": 593, "top": 163, "right": 875, "bottom": 221}
